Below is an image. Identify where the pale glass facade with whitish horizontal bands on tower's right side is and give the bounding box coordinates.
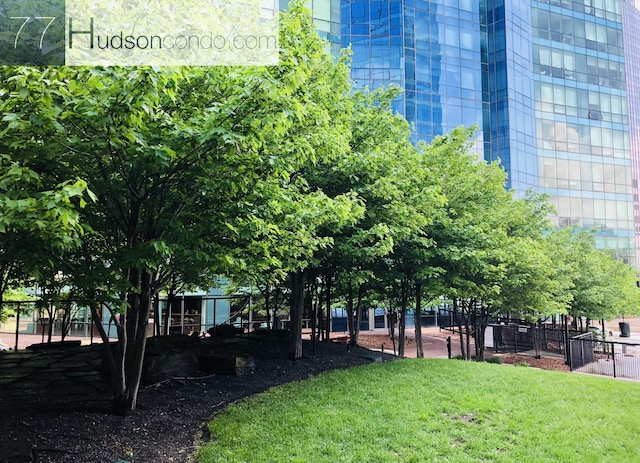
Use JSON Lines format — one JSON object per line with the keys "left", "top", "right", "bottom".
{"left": 531, "top": 0, "right": 636, "bottom": 264}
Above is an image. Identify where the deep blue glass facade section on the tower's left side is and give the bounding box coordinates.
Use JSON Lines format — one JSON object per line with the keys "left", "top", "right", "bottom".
{"left": 341, "top": 0, "right": 484, "bottom": 151}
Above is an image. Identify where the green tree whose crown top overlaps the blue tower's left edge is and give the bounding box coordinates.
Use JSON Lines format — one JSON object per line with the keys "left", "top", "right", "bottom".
{"left": 309, "top": 88, "right": 434, "bottom": 352}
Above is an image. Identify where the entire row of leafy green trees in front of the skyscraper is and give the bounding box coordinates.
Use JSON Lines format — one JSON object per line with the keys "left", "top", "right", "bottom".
{"left": 0, "top": 4, "right": 637, "bottom": 414}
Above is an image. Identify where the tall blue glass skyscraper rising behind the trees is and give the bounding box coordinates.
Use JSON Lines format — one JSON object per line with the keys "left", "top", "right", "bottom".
{"left": 336, "top": 0, "right": 640, "bottom": 265}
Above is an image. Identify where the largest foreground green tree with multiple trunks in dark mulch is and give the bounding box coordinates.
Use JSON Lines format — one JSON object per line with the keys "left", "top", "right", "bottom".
{"left": 2, "top": 1, "right": 360, "bottom": 414}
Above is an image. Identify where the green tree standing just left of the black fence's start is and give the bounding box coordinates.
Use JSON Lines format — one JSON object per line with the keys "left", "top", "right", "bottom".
{"left": 423, "top": 127, "right": 512, "bottom": 359}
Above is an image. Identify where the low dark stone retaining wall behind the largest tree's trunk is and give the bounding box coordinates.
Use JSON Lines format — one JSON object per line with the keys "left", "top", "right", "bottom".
{"left": 0, "top": 335, "right": 255, "bottom": 399}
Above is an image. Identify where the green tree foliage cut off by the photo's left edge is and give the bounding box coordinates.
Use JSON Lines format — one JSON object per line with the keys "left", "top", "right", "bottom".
{"left": 0, "top": 79, "right": 94, "bottom": 319}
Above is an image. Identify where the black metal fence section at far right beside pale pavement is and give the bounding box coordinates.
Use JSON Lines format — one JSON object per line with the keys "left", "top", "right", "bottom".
{"left": 569, "top": 333, "right": 640, "bottom": 380}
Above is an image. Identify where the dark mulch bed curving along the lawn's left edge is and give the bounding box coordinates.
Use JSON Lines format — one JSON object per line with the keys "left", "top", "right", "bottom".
{"left": 0, "top": 337, "right": 392, "bottom": 463}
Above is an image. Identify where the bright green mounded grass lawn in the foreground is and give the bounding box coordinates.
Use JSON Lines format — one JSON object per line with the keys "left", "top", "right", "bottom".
{"left": 200, "top": 359, "right": 640, "bottom": 463}
